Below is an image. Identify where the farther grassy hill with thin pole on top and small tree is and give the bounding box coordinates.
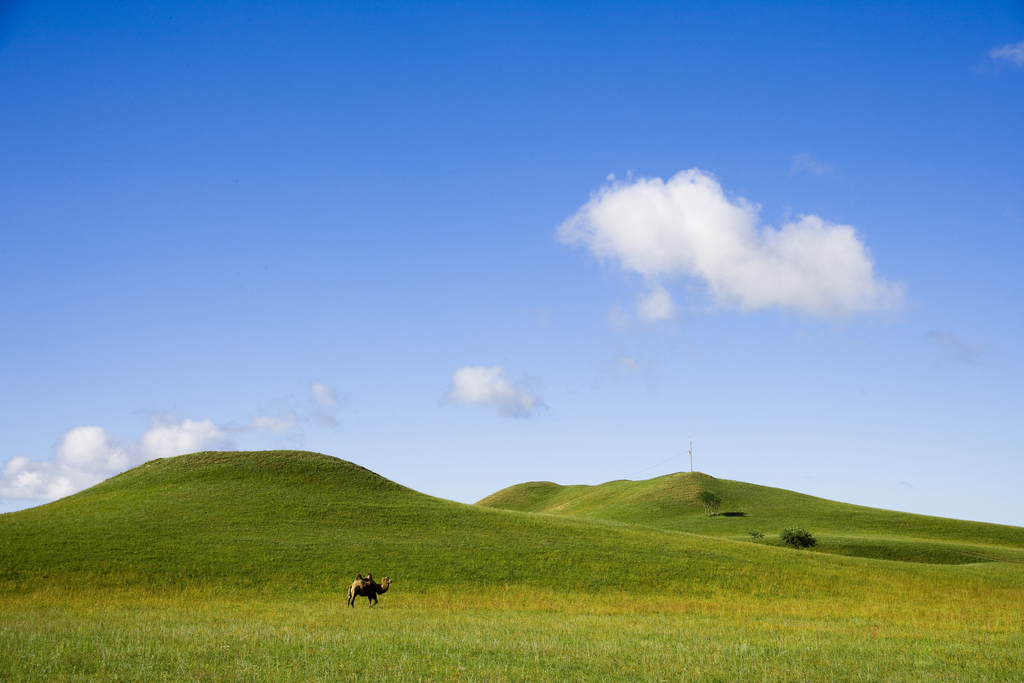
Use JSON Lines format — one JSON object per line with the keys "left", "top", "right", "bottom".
{"left": 476, "top": 472, "right": 1024, "bottom": 564}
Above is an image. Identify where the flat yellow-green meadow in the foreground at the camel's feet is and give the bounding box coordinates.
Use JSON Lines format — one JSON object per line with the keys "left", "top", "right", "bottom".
{"left": 0, "top": 583, "right": 1024, "bottom": 682}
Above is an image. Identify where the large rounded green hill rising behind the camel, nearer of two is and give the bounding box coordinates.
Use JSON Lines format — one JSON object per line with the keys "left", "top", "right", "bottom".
{"left": 0, "top": 452, "right": 1024, "bottom": 597}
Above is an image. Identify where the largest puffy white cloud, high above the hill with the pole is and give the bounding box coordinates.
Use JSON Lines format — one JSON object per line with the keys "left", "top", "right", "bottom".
{"left": 558, "top": 169, "right": 903, "bottom": 321}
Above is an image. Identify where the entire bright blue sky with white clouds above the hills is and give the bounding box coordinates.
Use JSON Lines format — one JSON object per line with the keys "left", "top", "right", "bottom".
{"left": 0, "top": 1, "right": 1024, "bottom": 525}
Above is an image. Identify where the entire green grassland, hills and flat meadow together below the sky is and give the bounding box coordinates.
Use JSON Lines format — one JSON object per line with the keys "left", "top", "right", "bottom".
{"left": 0, "top": 452, "right": 1024, "bottom": 681}
